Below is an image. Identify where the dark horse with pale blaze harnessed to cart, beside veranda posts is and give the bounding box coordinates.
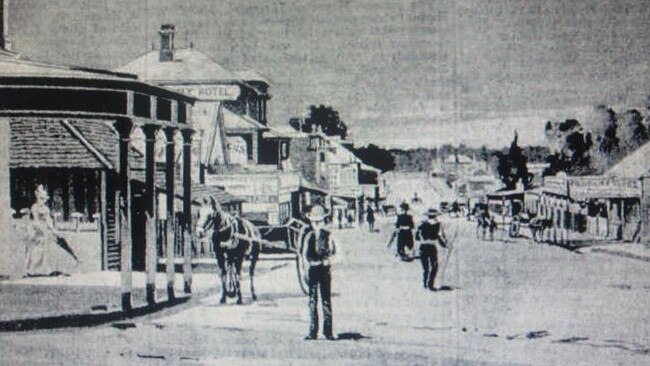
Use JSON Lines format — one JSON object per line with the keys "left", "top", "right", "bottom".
{"left": 196, "top": 198, "right": 262, "bottom": 304}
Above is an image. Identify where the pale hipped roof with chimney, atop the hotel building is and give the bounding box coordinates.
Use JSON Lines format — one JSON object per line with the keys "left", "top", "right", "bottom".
{"left": 116, "top": 48, "right": 241, "bottom": 84}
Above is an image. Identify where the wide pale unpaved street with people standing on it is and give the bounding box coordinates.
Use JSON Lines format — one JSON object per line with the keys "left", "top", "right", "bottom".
{"left": 0, "top": 219, "right": 650, "bottom": 365}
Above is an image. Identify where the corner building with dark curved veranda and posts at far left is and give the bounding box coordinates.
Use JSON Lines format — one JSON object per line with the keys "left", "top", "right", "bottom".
{"left": 0, "top": 50, "right": 194, "bottom": 308}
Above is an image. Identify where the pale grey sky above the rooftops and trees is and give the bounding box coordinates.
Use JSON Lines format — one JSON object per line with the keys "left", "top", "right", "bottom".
{"left": 9, "top": 0, "right": 650, "bottom": 148}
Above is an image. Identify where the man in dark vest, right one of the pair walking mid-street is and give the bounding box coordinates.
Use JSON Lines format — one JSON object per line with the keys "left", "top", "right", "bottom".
{"left": 415, "top": 208, "right": 447, "bottom": 291}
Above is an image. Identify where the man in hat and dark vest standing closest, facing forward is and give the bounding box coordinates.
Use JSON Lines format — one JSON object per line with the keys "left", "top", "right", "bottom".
{"left": 302, "top": 205, "right": 336, "bottom": 340}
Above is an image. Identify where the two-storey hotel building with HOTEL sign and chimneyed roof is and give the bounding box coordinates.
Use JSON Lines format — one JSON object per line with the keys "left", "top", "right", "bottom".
{"left": 118, "top": 25, "right": 299, "bottom": 225}
